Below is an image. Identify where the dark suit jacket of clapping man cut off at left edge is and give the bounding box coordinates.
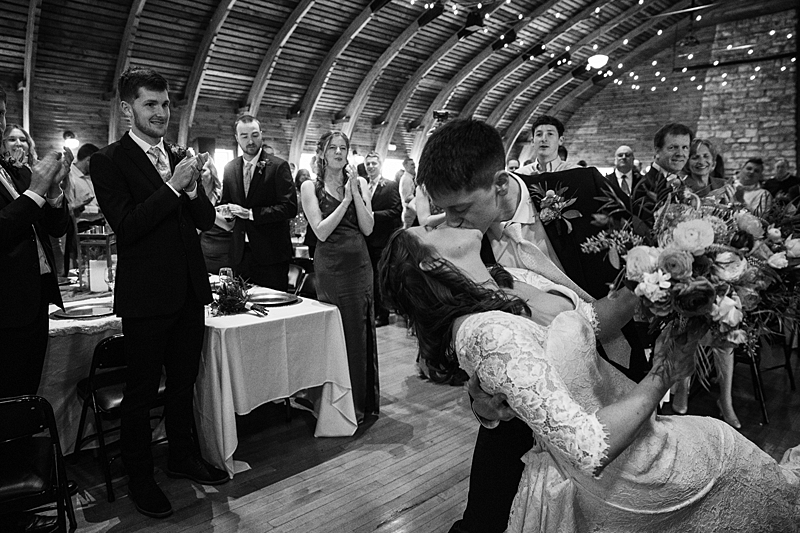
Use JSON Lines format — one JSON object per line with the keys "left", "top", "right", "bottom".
{"left": 0, "top": 161, "right": 69, "bottom": 327}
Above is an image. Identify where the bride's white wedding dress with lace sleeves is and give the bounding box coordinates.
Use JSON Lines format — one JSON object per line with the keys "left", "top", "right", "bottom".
{"left": 454, "top": 269, "right": 800, "bottom": 533}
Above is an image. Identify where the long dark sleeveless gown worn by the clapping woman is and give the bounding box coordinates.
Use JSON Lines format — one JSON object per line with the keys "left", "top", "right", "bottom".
{"left": 314, "top": 188, "right": 380, "bottom": 422}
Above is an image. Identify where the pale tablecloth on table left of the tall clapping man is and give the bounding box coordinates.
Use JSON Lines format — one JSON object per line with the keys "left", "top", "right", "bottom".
{"left": 44, "top": 296, "right": 122, "bottom": 454}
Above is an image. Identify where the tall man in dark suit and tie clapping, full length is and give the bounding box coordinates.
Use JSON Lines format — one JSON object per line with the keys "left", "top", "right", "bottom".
{"left": 91, "top": 68, "right": 228, "bottom": 518}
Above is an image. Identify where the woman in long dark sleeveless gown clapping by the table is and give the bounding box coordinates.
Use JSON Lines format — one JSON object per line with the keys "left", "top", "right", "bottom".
{"left": 300, "top": 132, "right": 379, "bottom": 423}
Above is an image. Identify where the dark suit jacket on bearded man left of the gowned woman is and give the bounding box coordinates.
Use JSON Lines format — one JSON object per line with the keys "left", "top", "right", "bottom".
{"left": 221, "top": 150, "right": 297, "bottom": 265}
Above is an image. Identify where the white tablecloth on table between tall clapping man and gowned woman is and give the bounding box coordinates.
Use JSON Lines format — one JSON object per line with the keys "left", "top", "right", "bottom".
{"left": 195, "top": 299, "right": 357, "bottom": 477}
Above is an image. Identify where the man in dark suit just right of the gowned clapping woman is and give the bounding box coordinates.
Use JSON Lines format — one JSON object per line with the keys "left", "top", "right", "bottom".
{"left": 364, "top": 152, "right": 403, "bottom": 327}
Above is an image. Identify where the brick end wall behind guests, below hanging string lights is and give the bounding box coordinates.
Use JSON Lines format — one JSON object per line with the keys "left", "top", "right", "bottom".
{"left": 565, "top": 10, "right": 797, "bottom": 176}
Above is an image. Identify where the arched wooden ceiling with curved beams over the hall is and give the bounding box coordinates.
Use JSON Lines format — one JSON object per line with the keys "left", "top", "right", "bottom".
{"left": 0, "top": 0, "right": 796, "bottom": 162}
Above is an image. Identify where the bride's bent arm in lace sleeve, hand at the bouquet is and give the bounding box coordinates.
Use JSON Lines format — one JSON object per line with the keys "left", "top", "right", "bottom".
{"left": 459, "top": 313, "right": 693, "bottom": 475}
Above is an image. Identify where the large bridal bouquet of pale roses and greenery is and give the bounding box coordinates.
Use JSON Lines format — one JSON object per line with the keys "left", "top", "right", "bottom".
{"left": 582, "top": 185, "right": 800, "bottom": 366}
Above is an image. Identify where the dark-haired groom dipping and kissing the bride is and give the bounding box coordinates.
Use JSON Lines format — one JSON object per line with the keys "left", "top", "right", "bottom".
{"left": 417, "top": 119, "right": 648, "bottom": 533}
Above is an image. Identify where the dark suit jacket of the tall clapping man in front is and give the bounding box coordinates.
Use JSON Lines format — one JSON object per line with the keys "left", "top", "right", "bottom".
{"left": 91, "top": 133, "right": 216, "bottom": 318}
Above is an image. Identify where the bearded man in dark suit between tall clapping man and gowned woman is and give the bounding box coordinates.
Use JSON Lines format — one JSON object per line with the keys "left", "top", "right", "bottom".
{"left": 221, "top": 115, "right": 297, "bottom": 291}
